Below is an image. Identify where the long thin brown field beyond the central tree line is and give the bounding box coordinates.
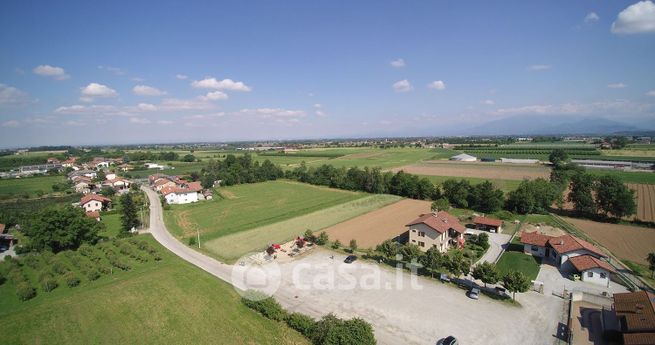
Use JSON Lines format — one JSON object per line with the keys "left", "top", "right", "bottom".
{"left": 392, "top": 161, "right": 550, "bottom": 180}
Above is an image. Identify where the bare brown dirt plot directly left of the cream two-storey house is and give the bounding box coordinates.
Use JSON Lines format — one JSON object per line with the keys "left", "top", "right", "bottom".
{"left": 325, "top": 199, "right": 430, "bottom": 248}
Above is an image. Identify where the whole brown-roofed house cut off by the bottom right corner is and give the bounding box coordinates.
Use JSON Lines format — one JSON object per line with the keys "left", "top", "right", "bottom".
{"left": 600, "top": 291, "right": 655, "bottom": 345}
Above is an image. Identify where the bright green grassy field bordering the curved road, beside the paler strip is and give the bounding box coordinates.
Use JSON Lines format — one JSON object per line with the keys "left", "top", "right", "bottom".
{"left": 165, "top": 180, "right": 366, "bottom": 242}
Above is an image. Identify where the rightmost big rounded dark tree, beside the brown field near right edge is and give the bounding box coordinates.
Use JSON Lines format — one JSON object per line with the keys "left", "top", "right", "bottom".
{"left": 594, "top": 175, "right": 636, "bottom": 218}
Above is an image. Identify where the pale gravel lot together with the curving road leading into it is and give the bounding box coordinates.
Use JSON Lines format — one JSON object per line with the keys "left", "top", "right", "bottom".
{"left": 142, "top": 187, "right": 566, "bottom": 345}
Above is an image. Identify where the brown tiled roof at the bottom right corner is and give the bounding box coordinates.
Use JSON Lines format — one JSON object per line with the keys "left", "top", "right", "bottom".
{"left": 614, "top": 291, "right": 655, "bottom": 336}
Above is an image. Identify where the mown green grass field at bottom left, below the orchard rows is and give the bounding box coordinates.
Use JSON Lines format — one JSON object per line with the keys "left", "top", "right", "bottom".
{"left": 0, "top": 236, "right": 307, "bottom": 344}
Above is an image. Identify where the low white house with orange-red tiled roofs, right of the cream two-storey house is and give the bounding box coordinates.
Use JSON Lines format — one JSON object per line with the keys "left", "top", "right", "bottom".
{"left": 521, "top": 232, "right": 616, "bottom": 286}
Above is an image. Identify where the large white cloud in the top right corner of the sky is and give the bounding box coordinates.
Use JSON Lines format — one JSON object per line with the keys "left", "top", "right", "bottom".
{"left": 612, "top": 0, "right": 655, "bottom": 34}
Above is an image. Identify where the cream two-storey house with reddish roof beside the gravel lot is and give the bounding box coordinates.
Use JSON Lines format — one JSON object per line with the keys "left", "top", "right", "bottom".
{"left": 407, "top": 211, "right": 466, "bottom": 253}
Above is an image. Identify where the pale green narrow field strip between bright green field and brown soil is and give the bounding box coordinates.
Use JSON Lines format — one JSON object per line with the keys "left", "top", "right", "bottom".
{"left": 202, "top": 194, "right": 402, "bottom": 262}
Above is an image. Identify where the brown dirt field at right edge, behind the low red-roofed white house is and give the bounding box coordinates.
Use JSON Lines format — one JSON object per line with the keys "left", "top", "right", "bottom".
{"left": 564, "top": 218, "right": 655, "bottom": 265}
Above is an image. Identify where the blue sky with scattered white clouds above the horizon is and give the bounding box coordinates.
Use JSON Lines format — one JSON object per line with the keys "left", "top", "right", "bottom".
{"left": 0, "top": 0, "right": 655, "bottom": 147}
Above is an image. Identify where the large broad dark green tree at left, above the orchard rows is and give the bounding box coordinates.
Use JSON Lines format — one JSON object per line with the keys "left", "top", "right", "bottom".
{"left": 23, "top": 206, "right": 104, "bottom": 253}
